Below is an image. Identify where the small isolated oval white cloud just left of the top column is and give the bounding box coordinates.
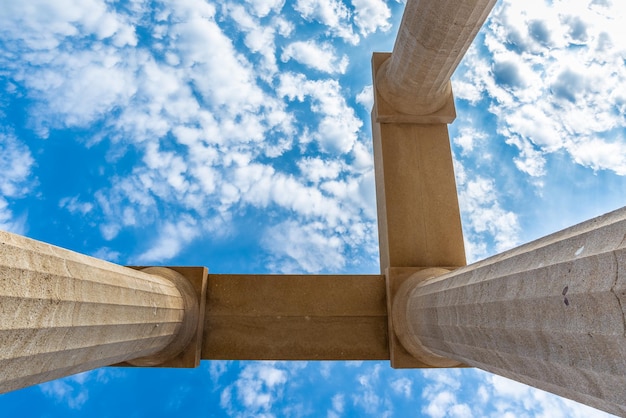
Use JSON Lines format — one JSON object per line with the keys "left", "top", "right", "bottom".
{"left": 281, "top": 41, "right": 348, "bottom": 74}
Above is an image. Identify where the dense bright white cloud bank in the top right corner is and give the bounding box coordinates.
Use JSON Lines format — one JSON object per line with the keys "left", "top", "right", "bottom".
{"left": 455, "top": 0, "right": 626, "bottom": 178}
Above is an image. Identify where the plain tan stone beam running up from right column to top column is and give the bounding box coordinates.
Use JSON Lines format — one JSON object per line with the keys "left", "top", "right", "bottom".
{"left": 372, "top": 114, "right": 465, "bottom": 272}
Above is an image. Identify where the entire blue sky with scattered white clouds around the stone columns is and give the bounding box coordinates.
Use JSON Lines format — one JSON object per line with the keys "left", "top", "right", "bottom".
{"left": 0, "top": 0, "right": 626, "bottom": 417}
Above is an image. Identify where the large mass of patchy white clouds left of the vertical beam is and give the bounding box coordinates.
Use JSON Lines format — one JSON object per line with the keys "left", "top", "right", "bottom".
{"left": 2, "top": 0, "right": 375, "bottom": 271}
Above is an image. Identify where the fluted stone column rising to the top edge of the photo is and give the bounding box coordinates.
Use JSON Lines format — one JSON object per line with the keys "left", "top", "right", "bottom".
{"left": 376, "top": 0, "right": 496, "bottom": 115}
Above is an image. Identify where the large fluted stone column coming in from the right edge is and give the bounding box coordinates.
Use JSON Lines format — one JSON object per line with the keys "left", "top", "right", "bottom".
{"left": 393, "top": 208, "right": 626, "bottom": 416}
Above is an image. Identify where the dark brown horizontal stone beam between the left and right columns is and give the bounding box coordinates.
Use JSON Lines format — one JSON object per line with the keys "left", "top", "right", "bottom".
{"left": 202, "top": 274, "right": 389, "bottom": 360}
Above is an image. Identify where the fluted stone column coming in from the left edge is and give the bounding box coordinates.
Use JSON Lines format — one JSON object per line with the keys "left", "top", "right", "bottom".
{"left": 0, "top": 231, "right": 198, "bottom": 393}
